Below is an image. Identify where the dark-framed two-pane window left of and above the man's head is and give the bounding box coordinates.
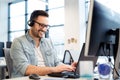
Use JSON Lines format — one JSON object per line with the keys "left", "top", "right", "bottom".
{"left": 8, "top": 0, "right": 46, "bottom": 41}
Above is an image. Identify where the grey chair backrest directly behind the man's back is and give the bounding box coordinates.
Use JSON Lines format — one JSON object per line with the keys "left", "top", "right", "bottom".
{"left": 3, "top": 48, "right": 13, "bottom": 78}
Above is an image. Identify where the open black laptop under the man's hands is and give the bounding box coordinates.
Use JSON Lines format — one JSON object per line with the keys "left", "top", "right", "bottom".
{"left": 48, "top": 44, "right": 85, "bottom": 78}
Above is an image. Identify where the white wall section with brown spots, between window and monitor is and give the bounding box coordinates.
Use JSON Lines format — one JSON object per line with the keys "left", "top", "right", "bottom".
{"left": 65, "top": 0, "right": 86, "bottom": 59}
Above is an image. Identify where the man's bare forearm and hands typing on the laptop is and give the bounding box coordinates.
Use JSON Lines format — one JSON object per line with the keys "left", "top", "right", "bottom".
{"left": 25, "top": 64, "right": 75, "bottom": 76}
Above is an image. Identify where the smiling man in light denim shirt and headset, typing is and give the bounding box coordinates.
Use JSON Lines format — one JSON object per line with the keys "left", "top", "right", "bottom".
{"left": 10, "top": 10, "right": 76, "bottom": 77}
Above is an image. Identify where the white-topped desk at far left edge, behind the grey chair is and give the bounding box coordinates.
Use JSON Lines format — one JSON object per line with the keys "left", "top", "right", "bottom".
{"left": 0, "top": 57, "right": 6, "bottom": 80}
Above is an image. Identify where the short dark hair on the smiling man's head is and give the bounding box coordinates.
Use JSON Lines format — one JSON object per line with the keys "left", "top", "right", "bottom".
{"left": 30, "top": 10, "right": 49, "bottom": 21}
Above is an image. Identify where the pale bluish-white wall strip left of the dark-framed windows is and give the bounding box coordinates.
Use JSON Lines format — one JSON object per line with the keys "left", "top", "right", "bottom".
{"left": 0, "top": 0, "right": 8, "bottom": 42}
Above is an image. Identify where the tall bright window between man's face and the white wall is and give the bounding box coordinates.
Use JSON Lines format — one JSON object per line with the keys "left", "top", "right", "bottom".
{"left": 48, "top": 0, "right": 65, "bottom": 59}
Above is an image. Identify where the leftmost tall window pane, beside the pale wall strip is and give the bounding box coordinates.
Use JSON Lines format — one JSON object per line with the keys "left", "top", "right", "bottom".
{"left": 8, "top": 1, "right": 25, "bottom": 41}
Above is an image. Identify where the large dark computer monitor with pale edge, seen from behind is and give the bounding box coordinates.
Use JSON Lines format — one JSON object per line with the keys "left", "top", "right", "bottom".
{"left": 84, "top": 0, "right": 120, "bottom": 56}
